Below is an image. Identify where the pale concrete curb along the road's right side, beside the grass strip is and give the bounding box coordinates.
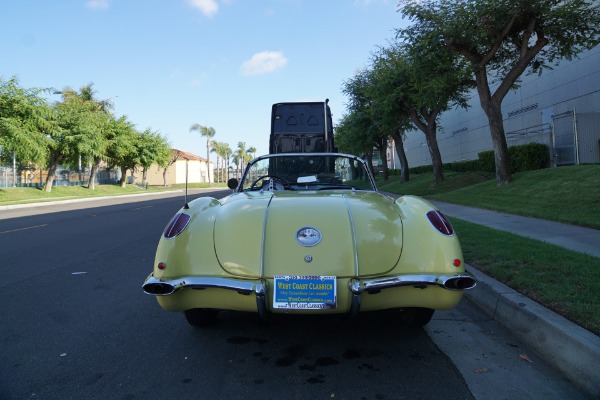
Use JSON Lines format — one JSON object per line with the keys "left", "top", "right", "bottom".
{"left": 465, "top": 265, "right": 600, "bottom": 398}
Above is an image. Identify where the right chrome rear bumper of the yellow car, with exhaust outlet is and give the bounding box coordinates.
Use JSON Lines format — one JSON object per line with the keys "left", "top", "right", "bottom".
{"left": 352, "top": 272, "right": 477, "bottom": 293}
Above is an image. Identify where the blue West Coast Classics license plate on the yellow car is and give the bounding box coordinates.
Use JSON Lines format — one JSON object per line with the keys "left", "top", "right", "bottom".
{"left": 273, "top": 275, "right": 337, "bottom": 310}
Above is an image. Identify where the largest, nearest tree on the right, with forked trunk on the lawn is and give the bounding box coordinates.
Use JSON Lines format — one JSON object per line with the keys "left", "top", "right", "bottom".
{"left": 399, "top": 0, "right": 600, "bottom": 184}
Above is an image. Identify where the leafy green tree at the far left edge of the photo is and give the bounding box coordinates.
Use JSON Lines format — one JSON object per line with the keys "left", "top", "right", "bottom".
{"left": 0, "top": 77, "right": 51, "bottom": 165}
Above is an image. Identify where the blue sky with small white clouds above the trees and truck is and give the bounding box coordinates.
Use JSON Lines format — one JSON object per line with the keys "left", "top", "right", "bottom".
{"left": 0, "top": 0, "right": 406, "bottom": 160}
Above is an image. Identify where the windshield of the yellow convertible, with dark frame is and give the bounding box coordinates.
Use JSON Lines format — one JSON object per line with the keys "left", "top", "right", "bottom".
{"left": 241, "top": 153, "right": 376, "bottom": 191}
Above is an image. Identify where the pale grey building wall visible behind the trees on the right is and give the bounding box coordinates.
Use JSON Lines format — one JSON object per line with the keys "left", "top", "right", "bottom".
{"left": 393, "top": 46, "right": 600, "bottom": 168}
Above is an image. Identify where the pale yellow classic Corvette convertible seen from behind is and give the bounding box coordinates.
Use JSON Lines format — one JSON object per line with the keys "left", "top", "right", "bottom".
{"left": 143, "top": 153, "right": 476, "bottom": 326}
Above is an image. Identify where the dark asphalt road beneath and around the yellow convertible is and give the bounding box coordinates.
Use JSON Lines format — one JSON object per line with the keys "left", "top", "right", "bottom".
{"left": 0, "top": 192, "right": 583, "bottom": 399}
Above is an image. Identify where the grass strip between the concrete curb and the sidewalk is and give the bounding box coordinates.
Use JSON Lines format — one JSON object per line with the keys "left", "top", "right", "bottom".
{"left": 450, "top": 218, "right": 600, "bottom": 335}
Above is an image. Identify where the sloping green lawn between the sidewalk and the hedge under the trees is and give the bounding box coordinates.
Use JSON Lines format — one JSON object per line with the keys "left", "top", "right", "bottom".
{"left": 378, "top": 165, "right": 600, "bottom": 229}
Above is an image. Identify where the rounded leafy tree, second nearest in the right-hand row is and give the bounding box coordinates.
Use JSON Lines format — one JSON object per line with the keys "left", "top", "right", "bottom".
{"left": 367, "top": 37, "right": 473, "bottom": 183}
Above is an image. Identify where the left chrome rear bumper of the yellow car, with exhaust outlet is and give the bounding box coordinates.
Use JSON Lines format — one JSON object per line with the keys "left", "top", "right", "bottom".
{"left": 142, "top": 275, "right": 267, "bottom": 296}
